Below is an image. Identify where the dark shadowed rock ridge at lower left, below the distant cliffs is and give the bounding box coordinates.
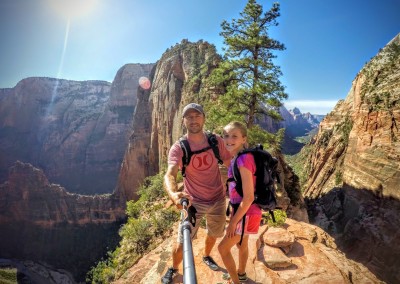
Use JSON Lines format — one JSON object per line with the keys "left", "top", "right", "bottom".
{"left": 0, "top": 162, "right": 125, "bottom": 283}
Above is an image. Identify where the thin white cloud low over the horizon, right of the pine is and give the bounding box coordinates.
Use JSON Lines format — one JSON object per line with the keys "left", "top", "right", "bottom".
{"left": 284, "top": 100, "right": 338, "bottom": 114}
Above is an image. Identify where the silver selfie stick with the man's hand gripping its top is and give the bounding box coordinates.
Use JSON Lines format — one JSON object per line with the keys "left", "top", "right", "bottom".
{"left": 181, "top": 198, "right": 197, "bottom": 284}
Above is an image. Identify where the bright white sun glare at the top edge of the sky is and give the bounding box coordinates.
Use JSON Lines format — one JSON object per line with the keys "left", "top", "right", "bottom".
{"left": 46, "top": 0, "right": 97, "bottom": 20}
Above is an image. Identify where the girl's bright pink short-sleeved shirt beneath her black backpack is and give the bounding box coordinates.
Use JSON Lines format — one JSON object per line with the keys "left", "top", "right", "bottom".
{"left": 228, "top": 153, "right": 262, "bottom": 215}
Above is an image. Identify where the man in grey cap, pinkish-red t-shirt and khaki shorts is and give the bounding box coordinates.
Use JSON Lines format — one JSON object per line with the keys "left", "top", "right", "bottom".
{"left": 161, "top": 103, "right": 231, "bottom": 284}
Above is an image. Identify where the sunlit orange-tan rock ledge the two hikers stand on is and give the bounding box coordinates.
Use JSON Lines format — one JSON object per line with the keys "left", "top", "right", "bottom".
{"left": 113, "top": 219, "right": 382, "bottom": 284}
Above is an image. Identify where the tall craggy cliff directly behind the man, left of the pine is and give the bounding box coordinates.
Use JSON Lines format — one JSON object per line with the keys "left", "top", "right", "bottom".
{"left": 117, "top": 40, "right": 219, "bottom": 200}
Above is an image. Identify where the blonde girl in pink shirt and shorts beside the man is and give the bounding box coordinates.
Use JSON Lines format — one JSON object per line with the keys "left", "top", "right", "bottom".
{"left": 218, "top": 121, "right": 262, "bottom": 284}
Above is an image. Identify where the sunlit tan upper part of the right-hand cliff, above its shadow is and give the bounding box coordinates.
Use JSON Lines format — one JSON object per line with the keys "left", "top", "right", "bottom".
{"left": 305, "top": 36, "right": 400, "bottom": 199}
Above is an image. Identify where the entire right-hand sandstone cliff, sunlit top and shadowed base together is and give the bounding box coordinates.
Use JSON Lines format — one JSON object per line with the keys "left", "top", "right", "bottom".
{"left": 304, "top": 34, "right": 400, "bottom": 283}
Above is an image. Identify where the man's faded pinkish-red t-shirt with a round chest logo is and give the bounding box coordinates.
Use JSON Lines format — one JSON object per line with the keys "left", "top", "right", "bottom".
{"left": 168, "top": 134, "right": 231, "bottom": 204}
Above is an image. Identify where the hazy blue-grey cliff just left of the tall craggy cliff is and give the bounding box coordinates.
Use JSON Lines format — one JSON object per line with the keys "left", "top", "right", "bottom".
{"left": 87, "top": 64, "right": 154, "bottom": 196}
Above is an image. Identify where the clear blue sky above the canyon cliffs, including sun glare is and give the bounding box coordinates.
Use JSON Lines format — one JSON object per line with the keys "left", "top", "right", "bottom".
{"left": 0, "top": 0, "right": 400, "bottom": 114}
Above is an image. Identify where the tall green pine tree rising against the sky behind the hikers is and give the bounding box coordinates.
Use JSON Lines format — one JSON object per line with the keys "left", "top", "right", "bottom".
{"left": 206, "top": 0, "right": 287, "bottom": 134}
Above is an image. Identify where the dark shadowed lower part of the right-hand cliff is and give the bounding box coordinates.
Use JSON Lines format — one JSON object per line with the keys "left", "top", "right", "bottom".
{"left": 309, "top": 185, "right": 400, "bottom": 283}
